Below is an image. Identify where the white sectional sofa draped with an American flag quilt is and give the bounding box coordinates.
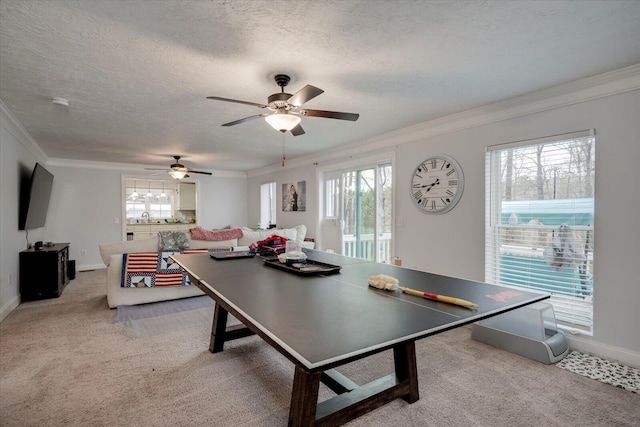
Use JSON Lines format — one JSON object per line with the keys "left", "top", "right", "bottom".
{"left": 99, "top": 225, "right": 307, "bottom": 308}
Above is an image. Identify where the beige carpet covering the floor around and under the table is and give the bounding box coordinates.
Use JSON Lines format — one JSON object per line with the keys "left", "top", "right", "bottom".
{"left": 0, "top": 271, "right": 640, "bottom": 427}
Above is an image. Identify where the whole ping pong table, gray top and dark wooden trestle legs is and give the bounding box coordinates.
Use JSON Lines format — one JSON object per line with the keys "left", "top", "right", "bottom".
{"left": 175, "top": 250, "right": 549, "bottom": 426}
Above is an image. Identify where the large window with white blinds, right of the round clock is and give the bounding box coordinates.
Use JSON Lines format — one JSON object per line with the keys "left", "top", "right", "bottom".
{"left": 485, "top": 130, "right": 595, "bottom": 334}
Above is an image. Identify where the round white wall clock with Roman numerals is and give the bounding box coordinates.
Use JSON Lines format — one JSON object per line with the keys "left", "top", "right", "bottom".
{"left": 411, "top": 155, "right": 464, "bottom": 214}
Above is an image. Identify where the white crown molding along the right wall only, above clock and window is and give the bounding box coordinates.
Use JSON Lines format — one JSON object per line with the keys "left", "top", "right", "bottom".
{"left": 247, "top": 64, "right": 640, "bottom": 177}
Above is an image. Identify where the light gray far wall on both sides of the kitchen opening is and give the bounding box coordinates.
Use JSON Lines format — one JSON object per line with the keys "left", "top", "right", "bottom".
{"left": 44, "top": 165, "right": 247, "bottom": 270}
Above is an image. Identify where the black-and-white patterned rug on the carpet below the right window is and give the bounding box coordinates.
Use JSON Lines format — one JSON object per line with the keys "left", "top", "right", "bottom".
{"left": 556, "top": 351, "right": 640, "bottom": 393}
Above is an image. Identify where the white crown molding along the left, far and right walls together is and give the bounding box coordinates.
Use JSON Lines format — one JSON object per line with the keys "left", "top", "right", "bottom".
{"left": 6, "top": 64, "right": 640, "bottom": 178}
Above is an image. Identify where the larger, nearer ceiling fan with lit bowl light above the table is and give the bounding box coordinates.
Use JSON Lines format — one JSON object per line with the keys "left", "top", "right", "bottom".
{"left": 207, "top": 74, "right": 360, "bottom": 136}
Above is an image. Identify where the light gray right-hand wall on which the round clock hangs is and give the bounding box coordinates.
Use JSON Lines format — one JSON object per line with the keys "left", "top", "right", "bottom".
{"left": 248, "top": 86, "right": 640, "bottom": 366}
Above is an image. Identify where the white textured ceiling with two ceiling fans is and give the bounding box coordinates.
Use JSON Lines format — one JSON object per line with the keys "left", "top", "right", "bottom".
{"left": 0, "top": 0, "right": 640, "bottom": 171}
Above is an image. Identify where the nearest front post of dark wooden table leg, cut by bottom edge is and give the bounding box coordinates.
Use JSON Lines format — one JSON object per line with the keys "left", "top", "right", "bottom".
{"left": 289, "top": 366, "right": 322, "bottom": 427}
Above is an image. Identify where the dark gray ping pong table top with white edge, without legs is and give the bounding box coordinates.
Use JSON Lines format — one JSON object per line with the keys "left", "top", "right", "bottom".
{"left": 175, "top": 251, "right": 549, "bottom": 370}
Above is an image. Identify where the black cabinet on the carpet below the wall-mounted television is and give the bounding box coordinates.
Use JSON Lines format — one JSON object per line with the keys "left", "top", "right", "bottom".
{"left": 20, "top": 243, "right": 69, "bottom": 302}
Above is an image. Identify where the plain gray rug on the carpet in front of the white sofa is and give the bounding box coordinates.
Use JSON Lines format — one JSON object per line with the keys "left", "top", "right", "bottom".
{"left": 112, "top": 296, "right": 214, "bottom": 337}
